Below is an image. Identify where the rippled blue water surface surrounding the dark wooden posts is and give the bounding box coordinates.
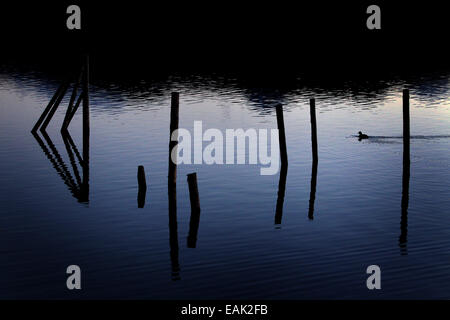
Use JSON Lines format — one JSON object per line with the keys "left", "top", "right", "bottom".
{"left": 0, "top": 66, "right": 450, "bottom": 299}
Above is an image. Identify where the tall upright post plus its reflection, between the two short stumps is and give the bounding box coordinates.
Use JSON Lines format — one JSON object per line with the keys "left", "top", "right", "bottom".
{"left": 167, "top": 92, "right": 180, "bottom": 280}
